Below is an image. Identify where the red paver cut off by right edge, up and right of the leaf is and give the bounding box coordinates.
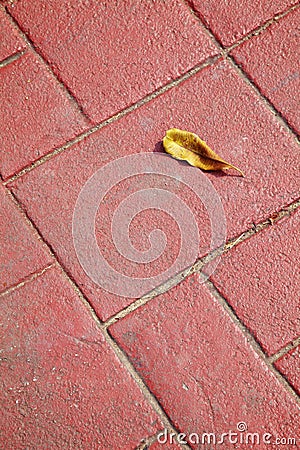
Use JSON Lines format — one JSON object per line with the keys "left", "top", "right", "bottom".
{"left": 232, "top": 8, "right": 300, "bottom": 133}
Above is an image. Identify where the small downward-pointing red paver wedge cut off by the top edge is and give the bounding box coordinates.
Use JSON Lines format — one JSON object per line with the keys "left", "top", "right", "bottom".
{"left": 189, "top": 0, "right": 297, "bottom": 47}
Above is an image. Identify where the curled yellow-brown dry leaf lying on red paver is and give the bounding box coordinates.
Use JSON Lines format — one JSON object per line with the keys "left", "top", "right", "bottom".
{"left": 163, "top": 128, "right": 244, "bottom": 176}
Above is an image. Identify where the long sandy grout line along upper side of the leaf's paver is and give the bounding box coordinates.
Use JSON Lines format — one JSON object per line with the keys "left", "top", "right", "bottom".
{"left": 3, "top": 55, "right": 221, "bottom": 185}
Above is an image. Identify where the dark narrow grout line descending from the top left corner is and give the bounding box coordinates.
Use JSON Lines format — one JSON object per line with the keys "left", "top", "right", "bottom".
{"left": 5, "top": 6, "right": 92, "bottom": 124}
